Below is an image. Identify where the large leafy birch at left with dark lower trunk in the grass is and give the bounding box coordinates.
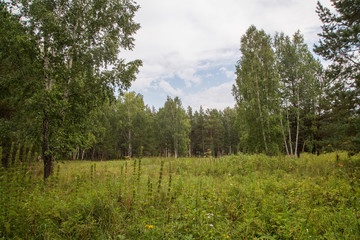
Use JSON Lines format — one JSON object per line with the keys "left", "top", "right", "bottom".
{"left": 8, "top": 0, "right": 141, "bottom": 179}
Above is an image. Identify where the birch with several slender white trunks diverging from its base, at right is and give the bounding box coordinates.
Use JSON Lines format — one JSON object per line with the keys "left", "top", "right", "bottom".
{"left": 274, "top": 31, "right": 320, "bottom": 157}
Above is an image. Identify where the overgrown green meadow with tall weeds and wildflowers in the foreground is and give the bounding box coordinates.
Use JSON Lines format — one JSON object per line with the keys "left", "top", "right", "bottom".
{"left": 0, "top": 153, "right": 360, "bottom": 239}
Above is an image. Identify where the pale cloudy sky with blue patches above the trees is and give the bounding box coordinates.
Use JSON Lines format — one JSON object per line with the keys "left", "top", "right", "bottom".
{"left": 122, "top": 0, "right": 330, "bottom": 110}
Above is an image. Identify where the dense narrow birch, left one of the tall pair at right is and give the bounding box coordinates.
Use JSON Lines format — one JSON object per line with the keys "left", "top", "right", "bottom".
{"left": 233, "top": 26, "right": 279, "bottom": 154}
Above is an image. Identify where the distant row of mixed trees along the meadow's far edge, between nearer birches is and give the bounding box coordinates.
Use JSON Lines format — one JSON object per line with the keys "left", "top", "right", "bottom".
{"left": 86, "top": 92, "right": 238, "bottom": 159}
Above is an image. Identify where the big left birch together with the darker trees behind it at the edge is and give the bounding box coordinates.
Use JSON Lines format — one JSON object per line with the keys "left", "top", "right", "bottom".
{"left": 0, "top": 0, "right": 142, "bottom": 178}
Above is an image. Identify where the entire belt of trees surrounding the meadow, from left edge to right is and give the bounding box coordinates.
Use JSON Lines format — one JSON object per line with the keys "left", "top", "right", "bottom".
{"left": 0, "top": 0, "right": 360, "bottom": 178}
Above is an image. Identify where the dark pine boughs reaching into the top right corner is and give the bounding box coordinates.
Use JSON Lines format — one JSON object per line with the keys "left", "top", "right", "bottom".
{"left": 314, "top": 0, "right": 360, "bottom": 86}
